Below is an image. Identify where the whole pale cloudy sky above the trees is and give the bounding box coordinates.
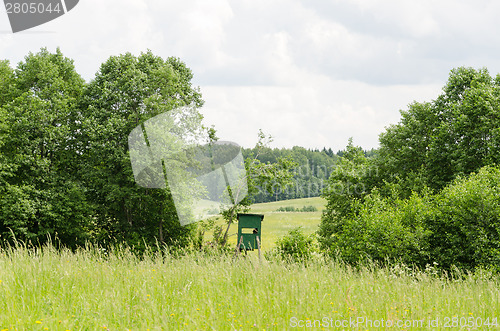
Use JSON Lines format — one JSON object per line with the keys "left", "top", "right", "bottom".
{"left": 0, "top": 0, "right": 500, "bottom": 151}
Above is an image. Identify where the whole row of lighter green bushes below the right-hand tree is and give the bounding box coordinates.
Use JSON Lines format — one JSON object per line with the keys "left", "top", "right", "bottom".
{"left": 320, "top": 167, "right": 500, "bottom": 270}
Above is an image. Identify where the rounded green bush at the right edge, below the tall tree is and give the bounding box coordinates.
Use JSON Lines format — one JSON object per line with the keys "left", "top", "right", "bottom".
{"left": 427, "top": 167, "right": 500, "bottom": 269}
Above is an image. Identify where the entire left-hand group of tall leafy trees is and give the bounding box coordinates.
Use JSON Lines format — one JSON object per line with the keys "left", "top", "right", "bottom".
{"left": 0, "top": 49, "right": 203, "bottom": 248}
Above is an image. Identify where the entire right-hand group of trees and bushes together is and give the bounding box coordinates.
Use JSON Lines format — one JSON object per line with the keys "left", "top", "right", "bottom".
{"left": 318, "top": 67, "right": 500, "bottom": 270}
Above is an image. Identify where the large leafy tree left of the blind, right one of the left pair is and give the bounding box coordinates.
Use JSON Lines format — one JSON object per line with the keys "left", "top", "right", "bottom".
{"left": 76, "top": 51, "right": 203, "bottom": 246}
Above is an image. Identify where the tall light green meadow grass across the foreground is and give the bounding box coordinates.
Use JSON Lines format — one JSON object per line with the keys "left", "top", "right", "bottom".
{"left": 0, "top": 246, "right": 500, "bottom": 330}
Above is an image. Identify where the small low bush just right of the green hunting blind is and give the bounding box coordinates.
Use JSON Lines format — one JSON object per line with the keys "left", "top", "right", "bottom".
{"left": 267, "top": 227, "right": 315, "bottom": 262}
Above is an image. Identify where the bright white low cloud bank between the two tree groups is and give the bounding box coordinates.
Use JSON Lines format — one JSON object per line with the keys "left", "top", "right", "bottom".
{"left": 202, "top": 77, "right": 440, "bottom": 149}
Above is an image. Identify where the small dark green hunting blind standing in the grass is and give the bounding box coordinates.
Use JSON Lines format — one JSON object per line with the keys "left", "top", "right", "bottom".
{"left": 237, "top": 214, "right": 264, "bottom": 251}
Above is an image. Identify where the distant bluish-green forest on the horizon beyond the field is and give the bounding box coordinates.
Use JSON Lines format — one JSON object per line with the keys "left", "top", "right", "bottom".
{"left": 243, "top": 146, "right": 376, "bottom": 203}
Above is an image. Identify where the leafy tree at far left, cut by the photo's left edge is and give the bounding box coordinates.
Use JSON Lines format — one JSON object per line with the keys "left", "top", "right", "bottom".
{"left": 0, "top": 49, "right": 89, "bottom": 247}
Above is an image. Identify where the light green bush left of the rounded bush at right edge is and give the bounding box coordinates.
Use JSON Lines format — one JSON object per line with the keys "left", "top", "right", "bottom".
{"left": 321, "top": 191, "right": 429, "bottom": 266}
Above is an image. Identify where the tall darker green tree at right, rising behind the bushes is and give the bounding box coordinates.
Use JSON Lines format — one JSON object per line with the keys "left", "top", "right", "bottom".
{"left": 379, "top": 67, "right": 500, "bottom": 195}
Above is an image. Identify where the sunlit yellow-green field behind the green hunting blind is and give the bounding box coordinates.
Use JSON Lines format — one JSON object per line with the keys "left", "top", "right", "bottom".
{"left": 206, "top": 198, "right": 326, "bottom": 251}
